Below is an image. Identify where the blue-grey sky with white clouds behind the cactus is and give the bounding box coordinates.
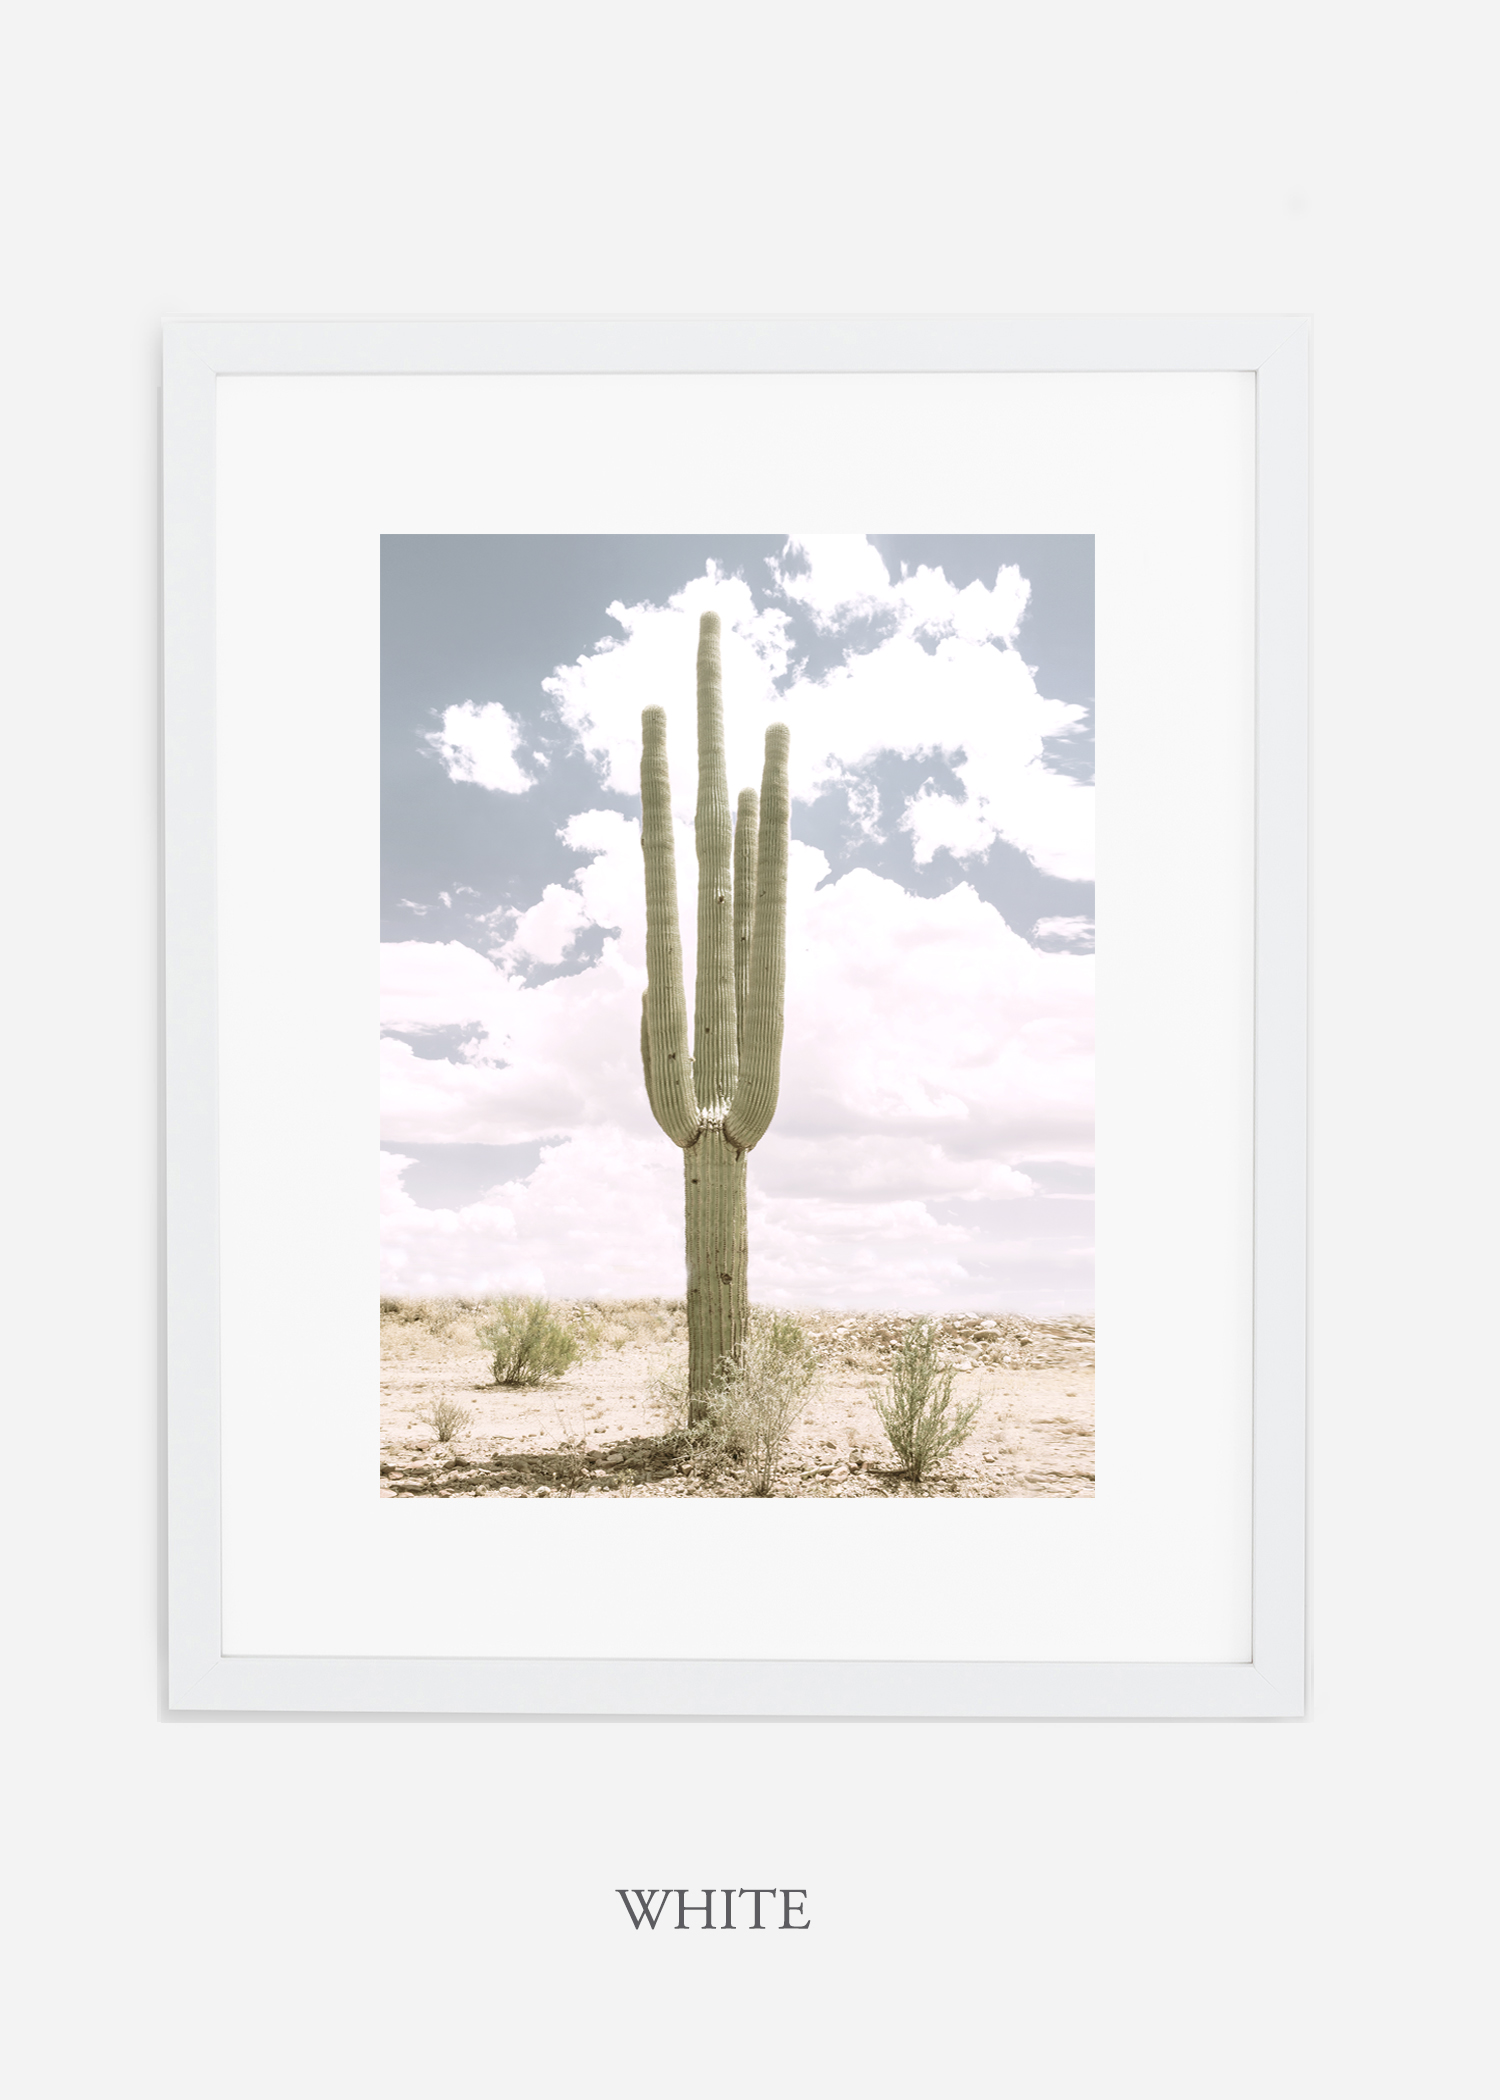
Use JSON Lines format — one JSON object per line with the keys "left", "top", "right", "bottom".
{"left": 380, "top": 536, "right": 1095, "bottom": 1313}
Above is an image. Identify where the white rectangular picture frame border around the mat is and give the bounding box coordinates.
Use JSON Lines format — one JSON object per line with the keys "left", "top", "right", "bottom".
{"left": 164, "top": 317, "right": 1309, "bottom": 1720}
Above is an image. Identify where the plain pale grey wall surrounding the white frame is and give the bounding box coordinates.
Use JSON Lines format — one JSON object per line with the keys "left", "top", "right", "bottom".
{"left": 0, "top": 0, "right": 1496, "bottom": 2100}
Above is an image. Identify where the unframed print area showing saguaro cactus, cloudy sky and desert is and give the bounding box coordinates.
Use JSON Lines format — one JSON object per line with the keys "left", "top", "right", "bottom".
{"left": 380, "top": 533, "right": 1095, "bottom": 1497}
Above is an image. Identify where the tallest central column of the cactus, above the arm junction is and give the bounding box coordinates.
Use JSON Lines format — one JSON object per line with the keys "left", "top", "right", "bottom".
{"left": 693, "top": 613, "right": 739, "bottom": 1119}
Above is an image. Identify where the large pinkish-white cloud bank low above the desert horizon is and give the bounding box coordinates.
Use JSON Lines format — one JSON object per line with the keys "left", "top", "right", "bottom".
{"left": 382, "top": 813, "right": 1092, "bottom": 1306}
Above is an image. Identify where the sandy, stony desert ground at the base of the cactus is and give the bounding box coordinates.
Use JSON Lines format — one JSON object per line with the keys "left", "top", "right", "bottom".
{"left": 380, "top": 1298, "right": 1095, "bottom": 1497}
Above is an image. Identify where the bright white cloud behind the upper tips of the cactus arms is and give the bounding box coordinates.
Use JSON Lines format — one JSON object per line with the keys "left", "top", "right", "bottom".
{"left": 546, "top": 536, "right": 1095, "bottom": 882}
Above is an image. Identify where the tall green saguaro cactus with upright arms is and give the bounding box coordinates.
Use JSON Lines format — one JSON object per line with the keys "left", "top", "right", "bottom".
{"left": 641, "top": 613, "right": 790, "bottom": 1420}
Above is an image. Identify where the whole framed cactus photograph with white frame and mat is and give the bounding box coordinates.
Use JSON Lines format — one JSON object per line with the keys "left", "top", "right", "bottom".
{"left": 164, "top": 317, "right": 1309, "bottom": 1718}
